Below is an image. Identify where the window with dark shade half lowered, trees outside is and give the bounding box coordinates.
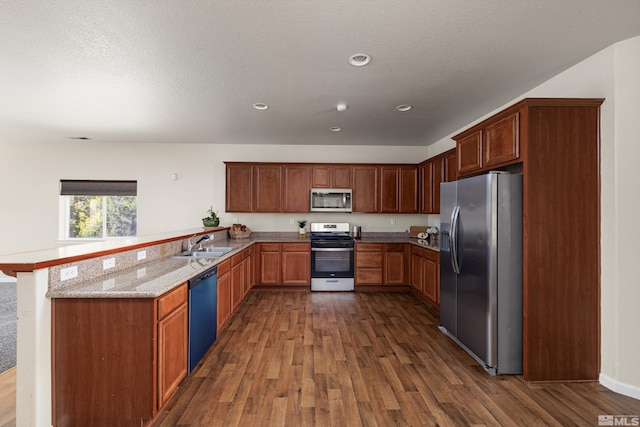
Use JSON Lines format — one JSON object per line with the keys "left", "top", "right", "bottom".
{"left": 60, "top": 180, "right": 137, "bottom": 239}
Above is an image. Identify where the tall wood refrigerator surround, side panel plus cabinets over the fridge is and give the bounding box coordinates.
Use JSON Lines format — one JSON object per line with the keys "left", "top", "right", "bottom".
{"left": 453, "top": 98, "right": 603, "bottom": 381}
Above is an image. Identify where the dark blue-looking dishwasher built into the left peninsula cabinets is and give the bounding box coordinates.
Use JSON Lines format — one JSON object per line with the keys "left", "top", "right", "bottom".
{"left": 189, "top": 266, "right": 218, "bottom": 372}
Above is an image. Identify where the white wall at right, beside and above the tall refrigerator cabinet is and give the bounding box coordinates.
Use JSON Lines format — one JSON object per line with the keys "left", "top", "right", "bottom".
{"left": 429, "top": 37, "right": 640, "bottom": 399}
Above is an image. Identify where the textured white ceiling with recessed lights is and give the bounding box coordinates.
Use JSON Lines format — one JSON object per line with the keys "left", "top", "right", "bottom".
{"left": 0, "top": 0, "right": 640, "bottom": 146}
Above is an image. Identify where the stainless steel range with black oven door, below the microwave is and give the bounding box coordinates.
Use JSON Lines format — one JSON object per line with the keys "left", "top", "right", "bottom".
{"left": 311, "top": 222, "right": 354, "bottom": 291}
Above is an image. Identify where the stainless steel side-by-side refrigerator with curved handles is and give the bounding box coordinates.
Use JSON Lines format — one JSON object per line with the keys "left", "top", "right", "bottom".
{"left": 440, "top": 172, "right": 524, "bottom": 375}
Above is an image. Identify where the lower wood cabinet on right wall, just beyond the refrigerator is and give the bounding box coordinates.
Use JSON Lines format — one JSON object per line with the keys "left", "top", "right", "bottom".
{"left": 411, "top": 245, "right": 440, "bottom": 307}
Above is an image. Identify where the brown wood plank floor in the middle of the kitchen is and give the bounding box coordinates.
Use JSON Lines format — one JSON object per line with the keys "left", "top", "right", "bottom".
{"left": 154, "top": 290, "right": 640, "bottom": 426}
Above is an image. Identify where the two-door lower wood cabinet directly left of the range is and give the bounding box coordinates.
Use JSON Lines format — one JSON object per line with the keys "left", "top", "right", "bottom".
{"left": 257, "top": 242, "right": 311, "bottom": 286}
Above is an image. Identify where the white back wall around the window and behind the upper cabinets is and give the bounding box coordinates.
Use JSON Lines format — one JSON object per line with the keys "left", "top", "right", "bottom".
{"left": 0, "top": 140, "right": 437, "bottom": 254}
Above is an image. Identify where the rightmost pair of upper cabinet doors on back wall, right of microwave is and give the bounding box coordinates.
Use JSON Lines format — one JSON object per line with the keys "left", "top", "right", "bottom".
{"left": 380, "top": 165, "right": 418, "bottom": 213}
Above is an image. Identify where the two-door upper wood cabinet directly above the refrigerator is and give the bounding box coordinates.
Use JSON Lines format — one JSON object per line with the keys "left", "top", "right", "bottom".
{"left": 454, "top": 112, "right": 520, "bottom": 175}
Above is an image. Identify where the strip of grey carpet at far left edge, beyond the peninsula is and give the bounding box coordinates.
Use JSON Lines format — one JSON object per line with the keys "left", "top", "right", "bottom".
{"left": 0, "top": 282, "right": 18, "bottom": 372}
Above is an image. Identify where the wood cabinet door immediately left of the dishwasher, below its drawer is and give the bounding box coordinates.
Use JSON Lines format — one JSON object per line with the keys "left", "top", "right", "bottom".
{"left": 158, "top": 300, "right": 189, "bottom": 408}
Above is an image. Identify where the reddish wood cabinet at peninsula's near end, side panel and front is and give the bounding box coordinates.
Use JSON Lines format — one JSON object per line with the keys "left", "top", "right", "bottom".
{"left": 52, "top": 283, "right": 188, "bottom": 426}
